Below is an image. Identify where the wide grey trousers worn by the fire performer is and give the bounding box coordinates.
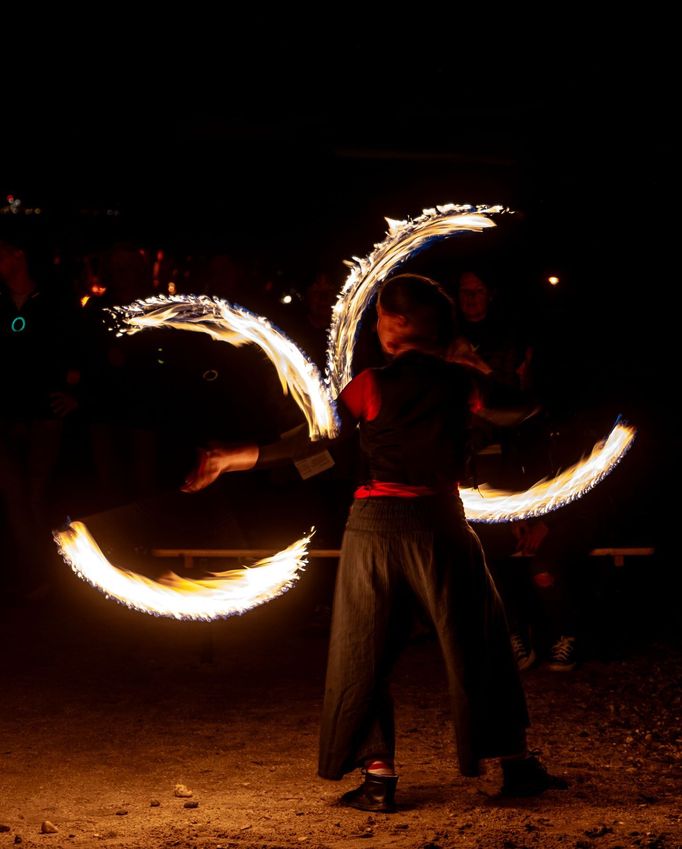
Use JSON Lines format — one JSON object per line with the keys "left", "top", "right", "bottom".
{"left": 319, "top": 495, "right": 528, "bottom": 779}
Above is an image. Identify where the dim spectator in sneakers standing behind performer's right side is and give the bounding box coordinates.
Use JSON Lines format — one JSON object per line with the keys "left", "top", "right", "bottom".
{"left": 450, "top": 271, "right": 589, "bottom": 671}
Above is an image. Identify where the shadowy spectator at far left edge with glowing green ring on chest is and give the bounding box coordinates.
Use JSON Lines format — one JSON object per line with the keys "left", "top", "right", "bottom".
{"left": 0, "top": 235, "right": 80, "bottom": 592}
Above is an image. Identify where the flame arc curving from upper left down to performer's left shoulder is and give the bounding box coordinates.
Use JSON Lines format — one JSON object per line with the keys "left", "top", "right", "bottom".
{"left": 112, "top": 295, "right": 338, "bottom": 439}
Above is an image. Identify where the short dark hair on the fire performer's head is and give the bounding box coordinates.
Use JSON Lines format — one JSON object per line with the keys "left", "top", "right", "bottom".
{"left": 379, "top": 274, "right": 455, "bottom": 349}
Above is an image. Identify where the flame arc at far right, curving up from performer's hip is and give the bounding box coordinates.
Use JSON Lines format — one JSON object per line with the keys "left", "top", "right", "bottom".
{"left": 460, "top": 424, "right": 636, "bottom": 522}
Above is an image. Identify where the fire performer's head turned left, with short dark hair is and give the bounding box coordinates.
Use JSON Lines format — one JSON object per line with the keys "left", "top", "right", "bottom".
{"left": 377, "top": 274, "right": 455, "bottom": 356}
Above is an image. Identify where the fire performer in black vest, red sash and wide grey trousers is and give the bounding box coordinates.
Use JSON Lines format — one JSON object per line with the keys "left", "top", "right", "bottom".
{"left": 183, "top": 274, "right": 567, "bottom": 813}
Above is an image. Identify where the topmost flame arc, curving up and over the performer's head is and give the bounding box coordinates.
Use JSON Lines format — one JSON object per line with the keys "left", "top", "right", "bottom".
{"left": 327, "top": 203, "right": 502, "bottom": 397}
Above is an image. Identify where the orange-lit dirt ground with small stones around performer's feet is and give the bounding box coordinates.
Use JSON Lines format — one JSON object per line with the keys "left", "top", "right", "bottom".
{"left": 0, "top": 548, "right": 682, "bottom": 849}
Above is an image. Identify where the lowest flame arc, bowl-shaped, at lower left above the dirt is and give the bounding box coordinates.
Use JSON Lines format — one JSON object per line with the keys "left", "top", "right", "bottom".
{"left": 54, "top": 522, "right": 313, "bottom": 620}
